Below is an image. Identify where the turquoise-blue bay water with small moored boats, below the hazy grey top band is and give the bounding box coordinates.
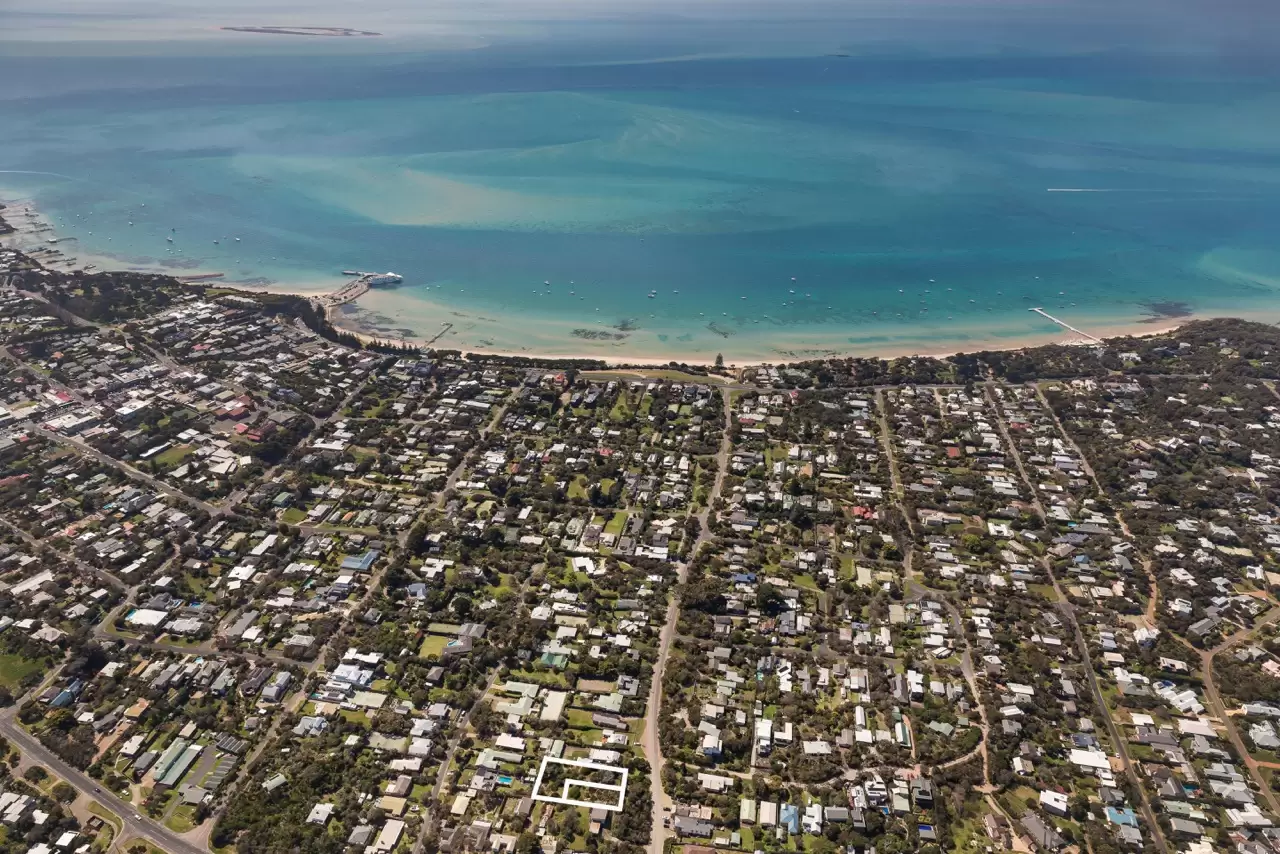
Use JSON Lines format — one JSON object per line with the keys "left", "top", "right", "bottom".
{"left": 0, "top": 8, "right": 1280, "bottom": 359}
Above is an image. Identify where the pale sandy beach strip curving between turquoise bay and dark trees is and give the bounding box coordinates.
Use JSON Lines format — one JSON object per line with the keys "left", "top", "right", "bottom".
{"left": 0, "top": 196, "right": 1228, "bottom": 367}
